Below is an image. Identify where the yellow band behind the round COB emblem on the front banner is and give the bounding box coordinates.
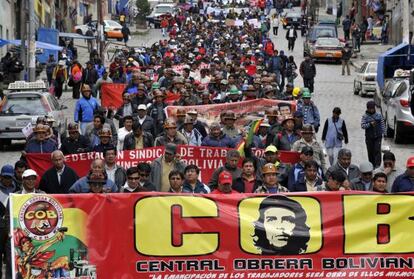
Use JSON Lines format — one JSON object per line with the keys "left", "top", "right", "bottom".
{"left": 11, "top": 194, "right": 88, "bottom": 245}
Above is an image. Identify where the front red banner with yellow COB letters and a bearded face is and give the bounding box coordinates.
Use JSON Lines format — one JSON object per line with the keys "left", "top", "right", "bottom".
{"left": 10, "top": 192, "right": 414, "bottom": 279}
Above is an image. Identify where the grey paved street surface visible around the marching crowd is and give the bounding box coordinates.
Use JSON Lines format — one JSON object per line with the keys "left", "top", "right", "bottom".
{"left": 0, "top": 19, "right": 414, "bottom": 171}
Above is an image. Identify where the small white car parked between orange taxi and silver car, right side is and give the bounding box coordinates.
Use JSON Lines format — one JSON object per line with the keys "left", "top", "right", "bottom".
{"left": 354, "top": 61, "right": 378, "bottom": 96}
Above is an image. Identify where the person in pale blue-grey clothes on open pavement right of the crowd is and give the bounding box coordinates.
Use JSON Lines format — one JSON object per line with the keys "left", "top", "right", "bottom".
{"left": 322, "top": 107, "right": 348, "bottom": 166}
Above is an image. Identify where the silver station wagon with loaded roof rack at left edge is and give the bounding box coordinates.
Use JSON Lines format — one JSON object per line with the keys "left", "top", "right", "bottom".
{"left": 0, "top": 81, "right": 67, "bottom": 147}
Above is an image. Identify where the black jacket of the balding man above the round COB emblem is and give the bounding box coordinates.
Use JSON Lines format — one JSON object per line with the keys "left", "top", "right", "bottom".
{"left": 39, "top": 165, "right": 79, "bottom": 194}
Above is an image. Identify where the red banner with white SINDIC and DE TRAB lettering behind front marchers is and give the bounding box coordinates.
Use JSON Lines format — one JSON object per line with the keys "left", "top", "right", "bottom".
{"left": 26, "top": 145, "right": 299, "bottom": 183}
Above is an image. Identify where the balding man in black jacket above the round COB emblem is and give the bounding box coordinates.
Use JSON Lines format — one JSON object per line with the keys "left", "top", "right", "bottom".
{"left": 39, "top": 150, "right": 79, "bottom": 194}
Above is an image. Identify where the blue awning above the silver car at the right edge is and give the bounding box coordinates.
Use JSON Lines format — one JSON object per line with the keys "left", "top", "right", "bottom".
{"left": 377, "top": 43, "right": 414, "bottom": 90}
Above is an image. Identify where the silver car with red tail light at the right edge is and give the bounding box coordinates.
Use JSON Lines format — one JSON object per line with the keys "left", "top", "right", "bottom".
{"left": 379, "top": 72, "right": 414, "bottom": 143}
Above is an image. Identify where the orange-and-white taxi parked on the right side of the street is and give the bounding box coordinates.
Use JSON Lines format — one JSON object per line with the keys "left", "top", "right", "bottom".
{"left": 309, "top": 38, "right": 344, "bottom": 63}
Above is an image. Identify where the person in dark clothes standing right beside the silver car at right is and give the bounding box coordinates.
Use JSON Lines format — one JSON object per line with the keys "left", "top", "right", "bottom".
{"left": 361, "top": 101, "right": 385, "bottom": 168}
